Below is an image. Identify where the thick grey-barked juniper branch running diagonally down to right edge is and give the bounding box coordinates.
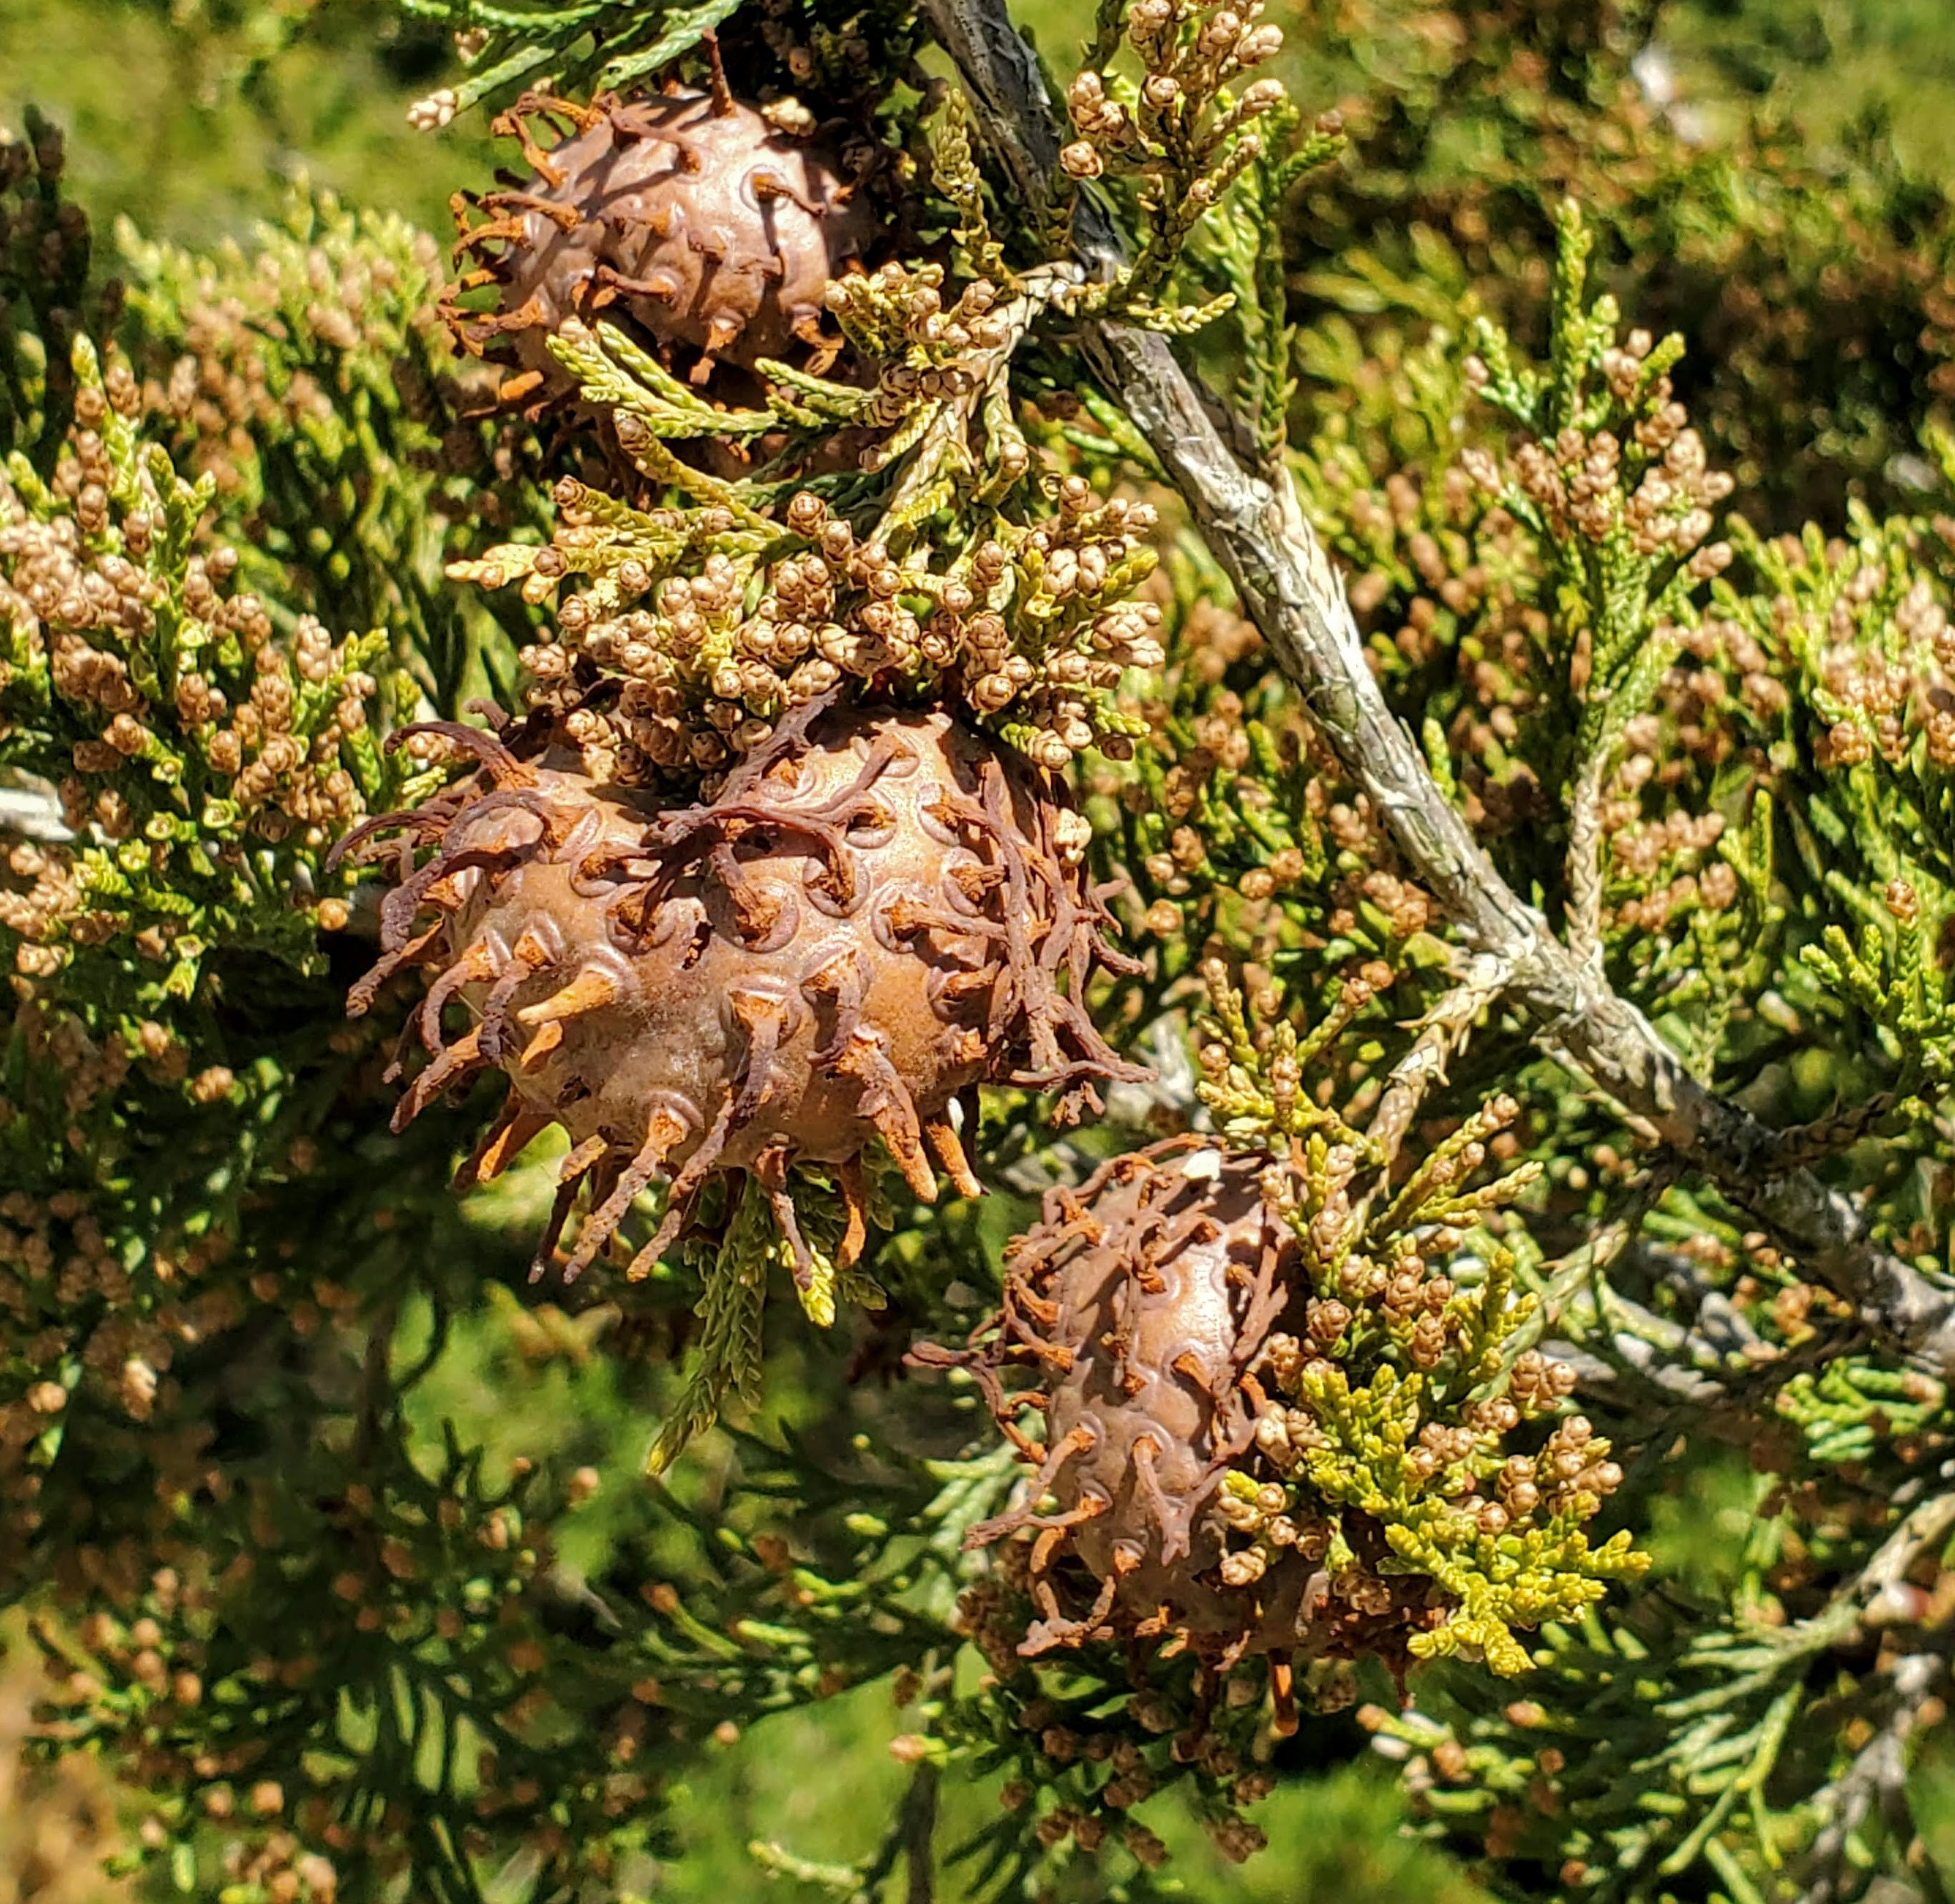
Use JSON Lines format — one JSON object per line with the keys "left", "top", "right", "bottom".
{"left": 925, "top": 0, "right": 1955, "bottom": 1376}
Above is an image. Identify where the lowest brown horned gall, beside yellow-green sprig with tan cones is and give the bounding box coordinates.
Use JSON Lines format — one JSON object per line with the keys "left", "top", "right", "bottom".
{"left": 915, "top": 1137, "right": 1426, "bottom": 1728}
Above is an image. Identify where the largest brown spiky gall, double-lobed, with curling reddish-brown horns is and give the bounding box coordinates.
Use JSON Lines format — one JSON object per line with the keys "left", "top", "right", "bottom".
{"left": 342, "top": 704, "right": 1144, "bottom": 1280}
